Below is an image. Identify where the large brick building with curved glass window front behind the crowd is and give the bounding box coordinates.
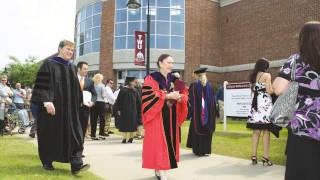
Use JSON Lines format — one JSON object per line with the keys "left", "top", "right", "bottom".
{"left": 75, "top": 0, "right": 320, "bottom": 83}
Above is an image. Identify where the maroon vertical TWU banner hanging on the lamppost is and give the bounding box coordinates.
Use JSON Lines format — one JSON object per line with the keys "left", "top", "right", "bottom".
{"left": 134, "top": 31, "right": 146, "bottom": 66}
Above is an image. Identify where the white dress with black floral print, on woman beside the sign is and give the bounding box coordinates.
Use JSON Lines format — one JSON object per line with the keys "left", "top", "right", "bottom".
{"left": 247, "top": 82, "right": 272, "bottom": 129}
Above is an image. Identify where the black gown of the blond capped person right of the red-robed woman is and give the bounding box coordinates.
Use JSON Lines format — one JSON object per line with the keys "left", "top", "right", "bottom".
{"left": 187, "top": 81, "right": 216, "bottom": 156}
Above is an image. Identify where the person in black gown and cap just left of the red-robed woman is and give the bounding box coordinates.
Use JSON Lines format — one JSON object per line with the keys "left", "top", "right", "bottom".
{"left": 114, "top": 77, "right": 141, "bottom": 143}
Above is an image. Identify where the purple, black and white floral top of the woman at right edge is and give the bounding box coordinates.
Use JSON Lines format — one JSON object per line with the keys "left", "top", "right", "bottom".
{"left": 279, "top": 54, "right": 320, "bottom": 141}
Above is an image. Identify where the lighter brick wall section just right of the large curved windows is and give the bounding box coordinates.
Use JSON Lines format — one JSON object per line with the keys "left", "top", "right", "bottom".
{"left": 184, "top": 0, "right": 221, "bottom": 82}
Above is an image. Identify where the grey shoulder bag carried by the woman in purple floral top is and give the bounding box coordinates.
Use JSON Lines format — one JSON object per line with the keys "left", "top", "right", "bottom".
{"left": 270, "top": 60, "right": 299, "bottom": 127}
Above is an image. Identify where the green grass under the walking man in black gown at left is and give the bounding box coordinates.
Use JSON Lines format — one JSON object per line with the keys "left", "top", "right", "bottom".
{"left": 0, "top": 136, "right": 102, "bottom": 180}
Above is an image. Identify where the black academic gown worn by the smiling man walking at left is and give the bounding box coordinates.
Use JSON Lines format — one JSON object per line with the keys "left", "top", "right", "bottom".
{"left": 32, "top": 57, "right": 83, "bottom": 164}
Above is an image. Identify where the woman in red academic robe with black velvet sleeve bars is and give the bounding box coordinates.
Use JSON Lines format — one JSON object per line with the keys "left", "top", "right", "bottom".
{"left": 142, "top": 54, "right": 188, "bottom": 180}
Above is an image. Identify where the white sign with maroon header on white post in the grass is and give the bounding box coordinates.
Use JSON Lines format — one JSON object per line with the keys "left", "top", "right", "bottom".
{"left": 223, "top": 81, "right": 252, "bottom": 130}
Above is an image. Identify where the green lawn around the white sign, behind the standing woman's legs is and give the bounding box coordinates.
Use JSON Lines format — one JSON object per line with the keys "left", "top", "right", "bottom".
{"left": 181, "top": 120, "right": 288, "bottom": 165}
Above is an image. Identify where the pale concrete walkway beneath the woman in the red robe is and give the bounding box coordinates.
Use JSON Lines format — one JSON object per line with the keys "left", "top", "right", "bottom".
{"left": 23, "top": 131, "right": 285, "bottom": 180}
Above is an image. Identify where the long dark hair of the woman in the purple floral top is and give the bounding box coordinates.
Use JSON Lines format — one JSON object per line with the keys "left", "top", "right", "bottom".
{"left": 299, "top": 21, "right": 320, "bottom": 70}
